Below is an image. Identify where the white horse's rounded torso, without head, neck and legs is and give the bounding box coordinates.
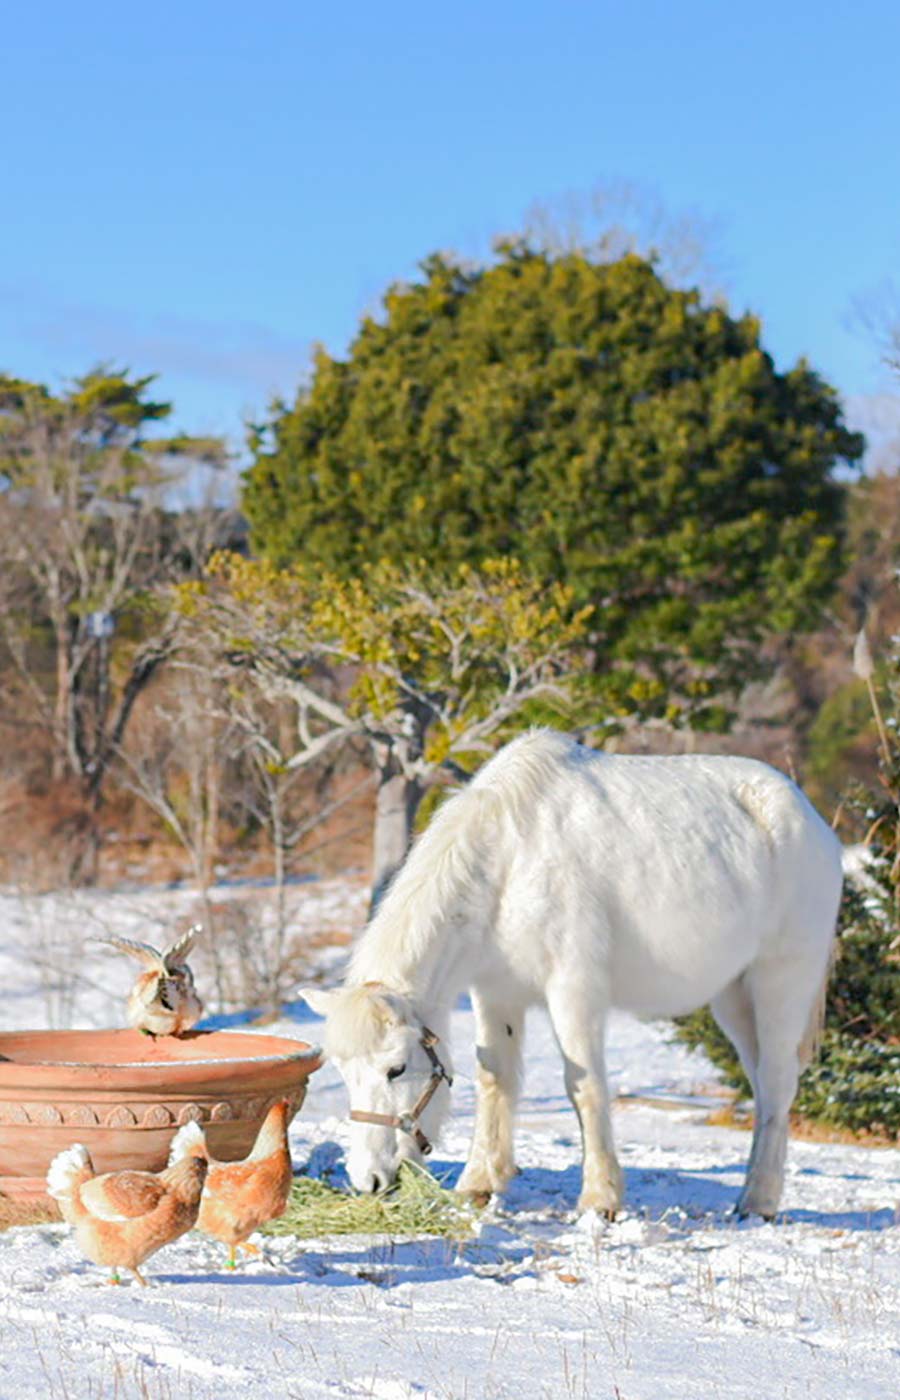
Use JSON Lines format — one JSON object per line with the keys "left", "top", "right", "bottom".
{"left": 477, "top": 732, "right": 841, "bottom": 1014}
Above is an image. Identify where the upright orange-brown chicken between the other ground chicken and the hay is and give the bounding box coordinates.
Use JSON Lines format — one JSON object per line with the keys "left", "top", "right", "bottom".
{"left": 169, "top": 1099, "right": 291, "bottom": 1268}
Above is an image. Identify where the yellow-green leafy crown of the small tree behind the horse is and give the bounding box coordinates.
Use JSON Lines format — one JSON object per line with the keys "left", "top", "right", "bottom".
{"left": 179, "top": 553, "right": 593, "bottom": 766}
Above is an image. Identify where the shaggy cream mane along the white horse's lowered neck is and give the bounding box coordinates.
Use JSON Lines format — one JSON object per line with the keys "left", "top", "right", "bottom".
{"left": 349, "top": 729, "right": 584, "bottom": 988}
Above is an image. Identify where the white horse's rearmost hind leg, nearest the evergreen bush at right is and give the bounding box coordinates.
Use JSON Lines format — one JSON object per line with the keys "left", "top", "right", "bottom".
{"left": 736, "top": 958, "right": 822, "bottom": 1219}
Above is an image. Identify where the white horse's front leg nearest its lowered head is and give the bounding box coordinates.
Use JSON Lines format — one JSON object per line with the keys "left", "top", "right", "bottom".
{"left": 456, "top": 993, "right": 525, "bottom": 1197}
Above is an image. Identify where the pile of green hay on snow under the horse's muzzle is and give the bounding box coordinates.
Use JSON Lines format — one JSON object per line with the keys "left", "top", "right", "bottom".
{"left": 265, "top": 1162, "right": 473, "bottom": 1239}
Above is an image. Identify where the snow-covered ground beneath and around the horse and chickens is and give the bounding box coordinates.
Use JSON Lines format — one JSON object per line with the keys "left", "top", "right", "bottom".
{"left": 0, "top": 885, "right": 900, "bottom": 1400}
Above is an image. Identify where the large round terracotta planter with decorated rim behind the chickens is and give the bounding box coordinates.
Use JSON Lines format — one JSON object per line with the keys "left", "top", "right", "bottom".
{"left": 0, "top": 1030, "right": 321, "bottom": 1198}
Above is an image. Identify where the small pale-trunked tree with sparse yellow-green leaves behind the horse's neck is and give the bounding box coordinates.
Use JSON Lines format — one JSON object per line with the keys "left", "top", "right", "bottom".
{"left": 182, "top": 554, "right": 592, "bottom": 904}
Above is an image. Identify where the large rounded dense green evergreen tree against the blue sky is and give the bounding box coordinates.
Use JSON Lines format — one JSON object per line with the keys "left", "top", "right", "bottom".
{"left": 245, "top": 244, "right": 862, "bottom": 725}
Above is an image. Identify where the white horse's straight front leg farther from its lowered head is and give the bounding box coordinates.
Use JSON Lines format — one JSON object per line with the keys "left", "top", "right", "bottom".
{"left": 547, "top": 983, "right": 623, "bottom": 1219}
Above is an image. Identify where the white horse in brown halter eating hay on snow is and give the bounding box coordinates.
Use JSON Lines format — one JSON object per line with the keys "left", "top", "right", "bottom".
{"left": 302, "top": 731, "right": 841, "bottom": 1217}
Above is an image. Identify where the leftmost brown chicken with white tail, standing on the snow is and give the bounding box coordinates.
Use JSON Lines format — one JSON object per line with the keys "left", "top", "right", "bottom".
{"left": 46, "top": 1142, "right": 206, "bottom": 1285}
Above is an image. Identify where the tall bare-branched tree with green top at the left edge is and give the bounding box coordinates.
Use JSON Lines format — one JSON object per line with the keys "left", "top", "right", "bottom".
{"left": 0, "top": 368, "right": 236, "bottom": 802}
